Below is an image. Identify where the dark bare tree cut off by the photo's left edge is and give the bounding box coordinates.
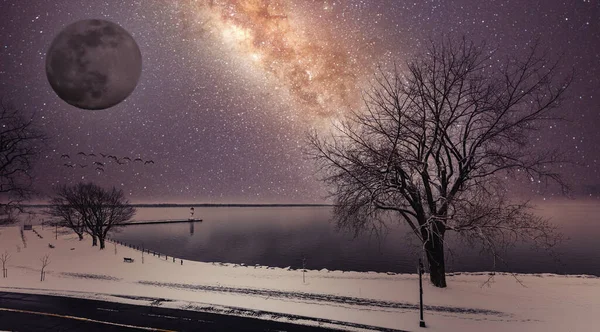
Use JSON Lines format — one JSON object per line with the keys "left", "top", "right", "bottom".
{"left": 0, "top": 99, "right": 46, "bottom": 225}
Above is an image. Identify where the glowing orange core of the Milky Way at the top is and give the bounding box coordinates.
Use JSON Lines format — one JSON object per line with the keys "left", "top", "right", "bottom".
{"left": 175, "top": 0, "right": 372, "bottom": 117}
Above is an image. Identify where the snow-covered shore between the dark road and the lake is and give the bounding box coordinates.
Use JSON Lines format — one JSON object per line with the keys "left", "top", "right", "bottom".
{"left": 0, "top": 226, "right": 600, "bottom": 332}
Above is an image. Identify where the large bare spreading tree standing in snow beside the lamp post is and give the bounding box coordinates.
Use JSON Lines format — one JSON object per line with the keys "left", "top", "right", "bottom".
{"left": 308, "top": 38, "right": 572, "bottom": 287}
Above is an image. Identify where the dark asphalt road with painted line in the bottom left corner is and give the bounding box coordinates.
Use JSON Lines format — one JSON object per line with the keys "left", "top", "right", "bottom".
{"left": 0, "top": 292, "right": 340, "bottom": 332}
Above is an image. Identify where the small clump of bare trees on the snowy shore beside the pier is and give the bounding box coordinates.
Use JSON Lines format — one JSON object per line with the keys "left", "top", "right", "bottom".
{"left": 50, "top": 183, "right": 135, "bottom": 249}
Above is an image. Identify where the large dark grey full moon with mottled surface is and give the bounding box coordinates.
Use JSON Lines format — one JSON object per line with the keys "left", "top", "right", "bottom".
{"left": 46, "top": 20, "right": 142, "bottom": 110}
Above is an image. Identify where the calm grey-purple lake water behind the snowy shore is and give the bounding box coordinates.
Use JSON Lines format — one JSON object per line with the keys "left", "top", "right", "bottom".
{"left": 105, "top": 202, "right": 600, "bottom": 275}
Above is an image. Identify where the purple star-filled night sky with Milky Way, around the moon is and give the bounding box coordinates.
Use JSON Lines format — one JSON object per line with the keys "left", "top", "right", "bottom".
{"left": 0, "top": 0, "right": 600, "bottom": 203}
